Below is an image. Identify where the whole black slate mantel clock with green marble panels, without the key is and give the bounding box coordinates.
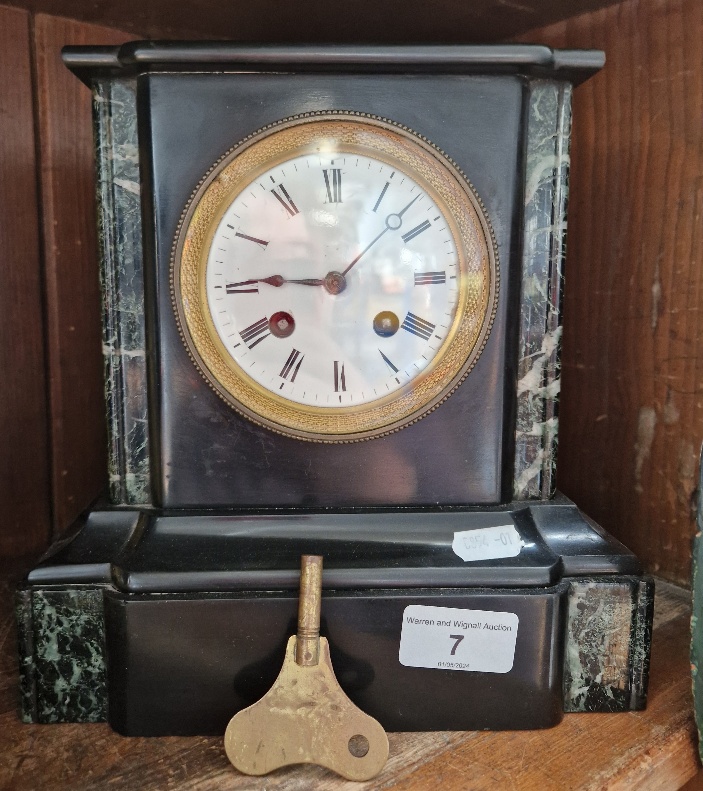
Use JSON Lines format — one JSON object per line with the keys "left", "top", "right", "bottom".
{"left": 18, "top": 42, "right": 653, "bottom": 734}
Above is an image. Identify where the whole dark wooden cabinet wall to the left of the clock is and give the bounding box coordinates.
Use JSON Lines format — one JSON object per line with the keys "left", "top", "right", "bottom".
{"left": 0, "top": 6, "right": 129, "bottom": 557}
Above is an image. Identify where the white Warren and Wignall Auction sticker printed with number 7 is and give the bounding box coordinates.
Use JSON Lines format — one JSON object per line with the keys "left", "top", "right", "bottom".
{"left": 398, "top": 604, "right": 518, "bottom": 673}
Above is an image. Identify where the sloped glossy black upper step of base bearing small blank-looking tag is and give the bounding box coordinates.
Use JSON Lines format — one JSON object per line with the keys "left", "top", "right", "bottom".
{"left": 28, "top": 497, "right": 640, "bottom": 593}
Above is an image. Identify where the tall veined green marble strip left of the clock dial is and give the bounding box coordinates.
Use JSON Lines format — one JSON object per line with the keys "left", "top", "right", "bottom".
{"left": 93, "top": 79, "right": 151, "bottom": 505}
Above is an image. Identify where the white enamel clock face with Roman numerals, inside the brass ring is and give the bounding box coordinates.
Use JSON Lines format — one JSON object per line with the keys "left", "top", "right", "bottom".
{"left": 206, "top": 151, "right": 460, "bottom": 409}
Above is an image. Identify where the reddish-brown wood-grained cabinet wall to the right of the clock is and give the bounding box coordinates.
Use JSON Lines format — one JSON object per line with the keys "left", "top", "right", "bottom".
{"left": 523, "top": 0, "right": 703, "bottom": 584}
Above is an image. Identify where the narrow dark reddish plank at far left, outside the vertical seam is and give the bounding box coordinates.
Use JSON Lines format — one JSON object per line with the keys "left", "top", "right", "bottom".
{"left": 0, "top": 6, "right": 51, "bottom": 557}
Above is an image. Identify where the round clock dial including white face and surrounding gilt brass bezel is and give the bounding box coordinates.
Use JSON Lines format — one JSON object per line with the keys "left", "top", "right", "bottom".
{"left": 174, "top": 115, "right": 497, "bottom": 441}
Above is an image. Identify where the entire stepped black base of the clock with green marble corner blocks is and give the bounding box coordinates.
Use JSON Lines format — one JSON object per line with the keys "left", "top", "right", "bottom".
{"left": 17, "top": 497, "right": 654, "bottom": 735}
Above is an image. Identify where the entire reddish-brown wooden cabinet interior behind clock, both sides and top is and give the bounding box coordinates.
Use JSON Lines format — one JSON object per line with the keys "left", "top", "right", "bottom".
{"left": 0, "top": 0, "right": 703, "bottom": 584}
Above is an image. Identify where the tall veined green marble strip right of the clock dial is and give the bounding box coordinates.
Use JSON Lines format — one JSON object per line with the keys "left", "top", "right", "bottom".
{"left": 513, "top": 80, "right": 571, "bottom": 500}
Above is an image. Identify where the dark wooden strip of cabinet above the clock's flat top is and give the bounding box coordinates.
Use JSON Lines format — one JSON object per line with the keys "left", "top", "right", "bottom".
{"left": 5, "top": 0, "right": 613, "bottom": 44}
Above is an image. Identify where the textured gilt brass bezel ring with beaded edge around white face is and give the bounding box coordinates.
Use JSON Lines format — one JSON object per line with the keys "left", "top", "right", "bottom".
{"left": 171, "top": 111, "right": 499, "bottom": 443}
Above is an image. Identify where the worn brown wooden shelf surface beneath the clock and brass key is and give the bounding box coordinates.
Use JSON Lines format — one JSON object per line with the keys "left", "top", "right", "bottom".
{"left": 0, "top": 566, "right": 698, "bottom": 791}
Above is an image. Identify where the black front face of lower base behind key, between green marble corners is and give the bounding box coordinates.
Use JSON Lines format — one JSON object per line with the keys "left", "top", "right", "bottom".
{"left": 106, "top": 583, "right": 568, "bottom": 735}
